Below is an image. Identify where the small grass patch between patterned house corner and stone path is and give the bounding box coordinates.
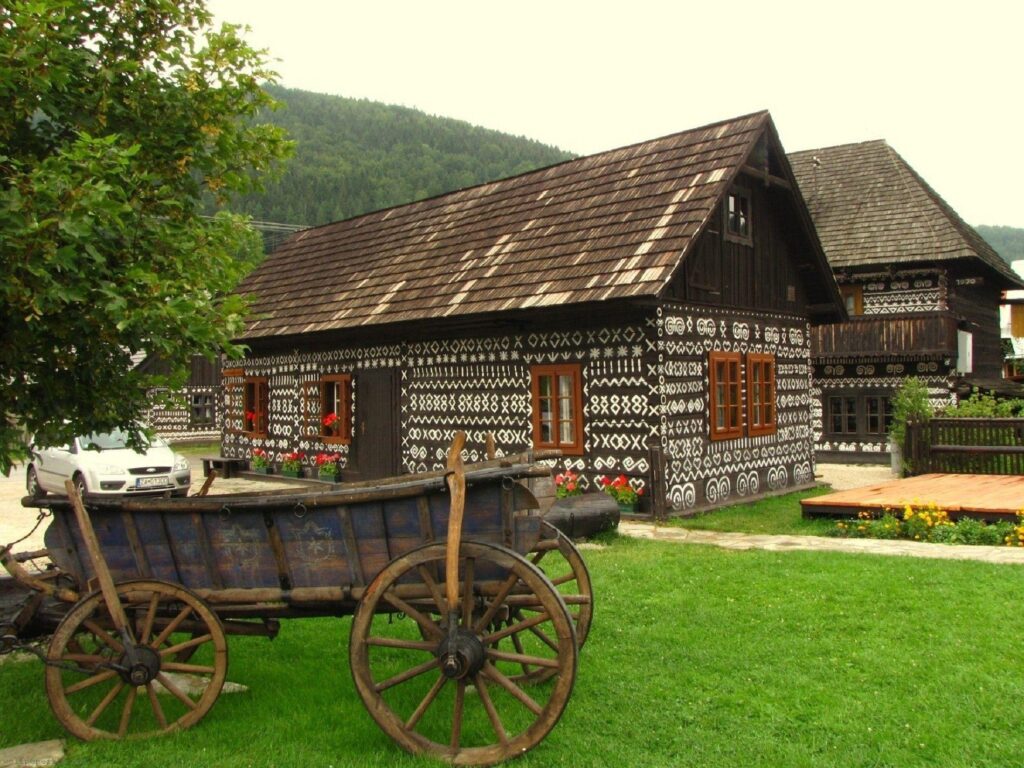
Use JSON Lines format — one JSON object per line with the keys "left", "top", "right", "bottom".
{"left": 668, "top": 486, "right": 836, "bottom": 536}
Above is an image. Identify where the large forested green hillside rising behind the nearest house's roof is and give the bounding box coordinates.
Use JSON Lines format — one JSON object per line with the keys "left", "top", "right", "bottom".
{"left": 236, "top": 86, "right": 572, "bottom": 225}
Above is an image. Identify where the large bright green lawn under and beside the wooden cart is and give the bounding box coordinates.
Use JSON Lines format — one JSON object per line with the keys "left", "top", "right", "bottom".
{"left": 0, "top": 539, "right": 1024, "bottom": 768}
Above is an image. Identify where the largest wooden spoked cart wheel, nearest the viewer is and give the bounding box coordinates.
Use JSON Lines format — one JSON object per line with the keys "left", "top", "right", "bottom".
{"left": 349, "top": 542, "right": 577, "bottom": 765}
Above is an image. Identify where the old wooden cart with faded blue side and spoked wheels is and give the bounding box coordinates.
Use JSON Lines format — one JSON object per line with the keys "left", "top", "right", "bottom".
{"left": 0, "top": 435, "right": 592, "bottom": 765}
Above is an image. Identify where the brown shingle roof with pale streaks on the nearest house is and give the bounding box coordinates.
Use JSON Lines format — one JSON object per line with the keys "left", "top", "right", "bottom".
{"left": 239, "top": 112, "right": 827, "bottom": 338}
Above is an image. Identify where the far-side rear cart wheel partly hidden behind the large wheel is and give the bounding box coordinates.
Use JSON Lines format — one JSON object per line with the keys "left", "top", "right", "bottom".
{"left": 498, "top": 520, "right": 594, "bottom": 683}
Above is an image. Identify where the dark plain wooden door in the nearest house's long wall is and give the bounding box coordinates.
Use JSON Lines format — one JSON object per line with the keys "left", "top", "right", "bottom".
{"left": 345, "top": 369, "right": 400, "bottom": 480}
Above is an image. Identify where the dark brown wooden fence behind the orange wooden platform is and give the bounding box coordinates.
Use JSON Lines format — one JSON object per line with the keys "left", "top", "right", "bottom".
{"left": 904, "top": 419, "right": 1024, "bottom": 475}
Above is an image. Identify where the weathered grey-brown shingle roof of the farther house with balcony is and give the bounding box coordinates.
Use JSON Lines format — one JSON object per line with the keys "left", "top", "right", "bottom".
{"left": 790, "top": 140, "right": 1020, "bottom": 287}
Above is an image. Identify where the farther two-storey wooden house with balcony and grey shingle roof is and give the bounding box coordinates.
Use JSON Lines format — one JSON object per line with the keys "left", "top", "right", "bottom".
{"left": 790, "top": 140, "right": 1022, "bottom": 461}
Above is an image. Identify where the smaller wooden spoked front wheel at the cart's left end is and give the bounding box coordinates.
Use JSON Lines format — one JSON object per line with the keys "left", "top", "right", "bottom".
{"left": 46, "top": 581, "right": 227, "bottom": 741}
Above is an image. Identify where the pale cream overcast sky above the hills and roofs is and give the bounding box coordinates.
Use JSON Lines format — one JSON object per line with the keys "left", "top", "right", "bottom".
{"left": 209, "top": 0, "right": 1024, "bottom": 227}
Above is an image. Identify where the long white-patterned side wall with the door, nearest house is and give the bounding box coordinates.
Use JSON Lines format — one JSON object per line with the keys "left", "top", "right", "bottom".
{"left": 223, "top": 322, "right": 658, "bottom": 495}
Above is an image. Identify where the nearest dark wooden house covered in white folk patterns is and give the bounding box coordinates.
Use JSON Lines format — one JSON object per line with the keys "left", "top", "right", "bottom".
{"left": 221, "top": 112, "right": 844, "bottom": 518}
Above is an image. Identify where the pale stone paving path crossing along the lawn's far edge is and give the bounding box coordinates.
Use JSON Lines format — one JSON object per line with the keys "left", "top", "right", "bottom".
{"left": 618, "top": 520, "right": 1024, "bottom": 565}
